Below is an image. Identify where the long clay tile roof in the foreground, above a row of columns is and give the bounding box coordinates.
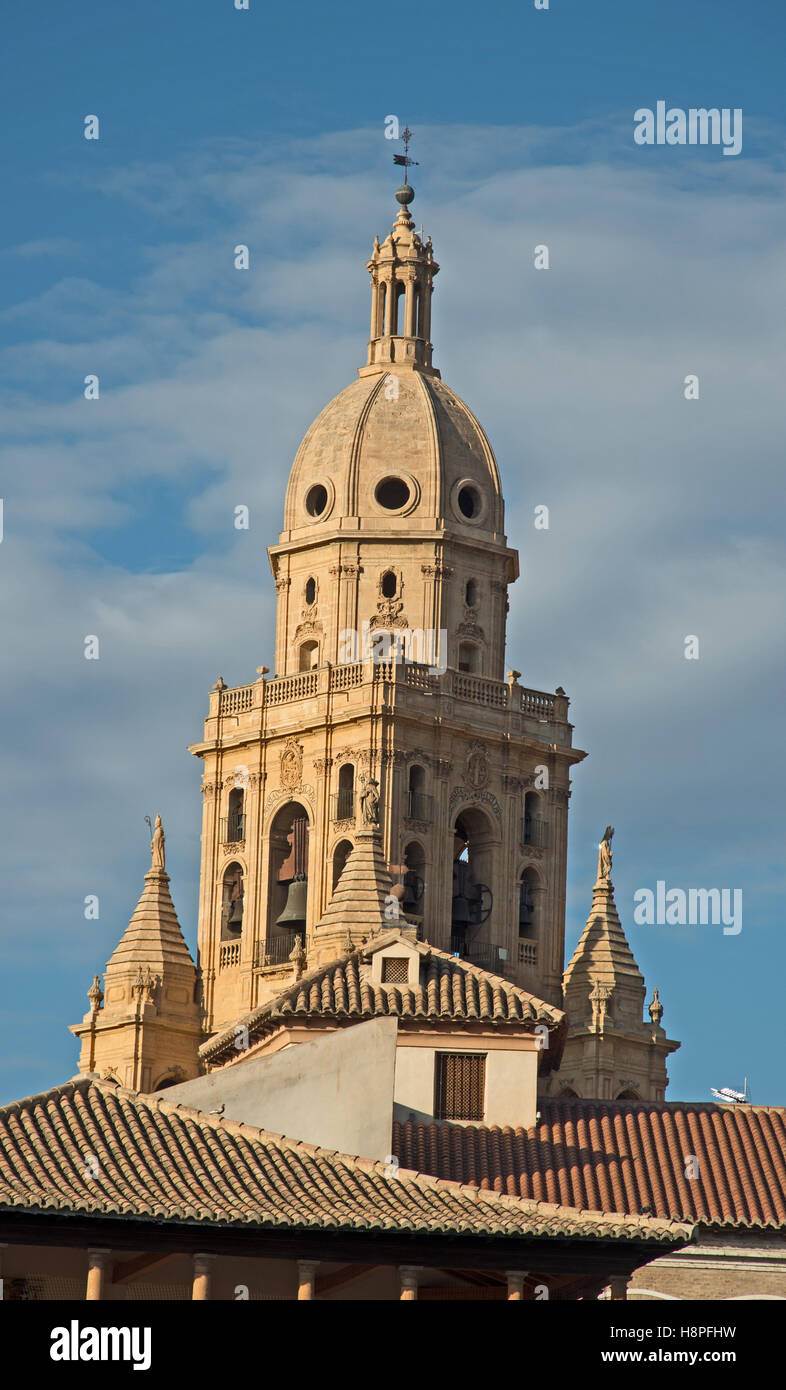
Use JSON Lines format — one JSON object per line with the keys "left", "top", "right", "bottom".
{"left": 0, "top": 1076, "right": 691, "bottom": 1247}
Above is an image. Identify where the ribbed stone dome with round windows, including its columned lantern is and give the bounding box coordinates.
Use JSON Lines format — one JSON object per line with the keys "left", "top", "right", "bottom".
{"left": 281, "top": 185, "right": 505, "bottom": 548}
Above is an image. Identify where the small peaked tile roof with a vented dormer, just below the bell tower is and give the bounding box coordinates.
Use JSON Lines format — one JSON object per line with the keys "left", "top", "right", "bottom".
{"left": 199, "top": 942, "right": 565, "bottom": 1068}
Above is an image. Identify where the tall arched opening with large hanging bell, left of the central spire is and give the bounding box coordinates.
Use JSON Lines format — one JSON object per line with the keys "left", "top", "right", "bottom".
{"left": 267, "top": 801, "right": 309, "bottom": 963}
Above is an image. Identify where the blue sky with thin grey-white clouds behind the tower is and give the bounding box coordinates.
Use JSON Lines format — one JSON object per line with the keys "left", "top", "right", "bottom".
{"left": 0, "top": 0, "right": 786, "bottom": 1104}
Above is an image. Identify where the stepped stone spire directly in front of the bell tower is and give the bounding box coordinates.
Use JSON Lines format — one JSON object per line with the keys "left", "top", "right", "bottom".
{"left": 314, "top": 826, "right": 399, "bottom": 965}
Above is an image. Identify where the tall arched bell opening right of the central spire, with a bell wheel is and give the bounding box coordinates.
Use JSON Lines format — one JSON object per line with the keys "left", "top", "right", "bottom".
{"left": 451, "top": 808, "right": 498, "bottom": 965}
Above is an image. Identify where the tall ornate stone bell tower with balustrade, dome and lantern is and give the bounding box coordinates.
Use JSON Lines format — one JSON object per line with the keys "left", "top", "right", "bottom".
{"left": 191, "top": 176, "right": 584, "bottom": 1031}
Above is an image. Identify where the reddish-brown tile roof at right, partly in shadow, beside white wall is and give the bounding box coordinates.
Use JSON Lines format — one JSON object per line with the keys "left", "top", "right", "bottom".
{"left": 392, "top": 1099, "right": 786, "bottom": 1227}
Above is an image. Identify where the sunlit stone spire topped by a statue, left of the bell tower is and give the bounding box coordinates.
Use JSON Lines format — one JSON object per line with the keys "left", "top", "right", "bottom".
{"left": 71, "top": 816, "right": 202, "bottom": 1091}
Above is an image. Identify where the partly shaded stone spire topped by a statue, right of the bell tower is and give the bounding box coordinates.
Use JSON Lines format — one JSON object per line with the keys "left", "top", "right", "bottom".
{"left": 552, "top": 826, "right": 679, "bottom": 1101}
